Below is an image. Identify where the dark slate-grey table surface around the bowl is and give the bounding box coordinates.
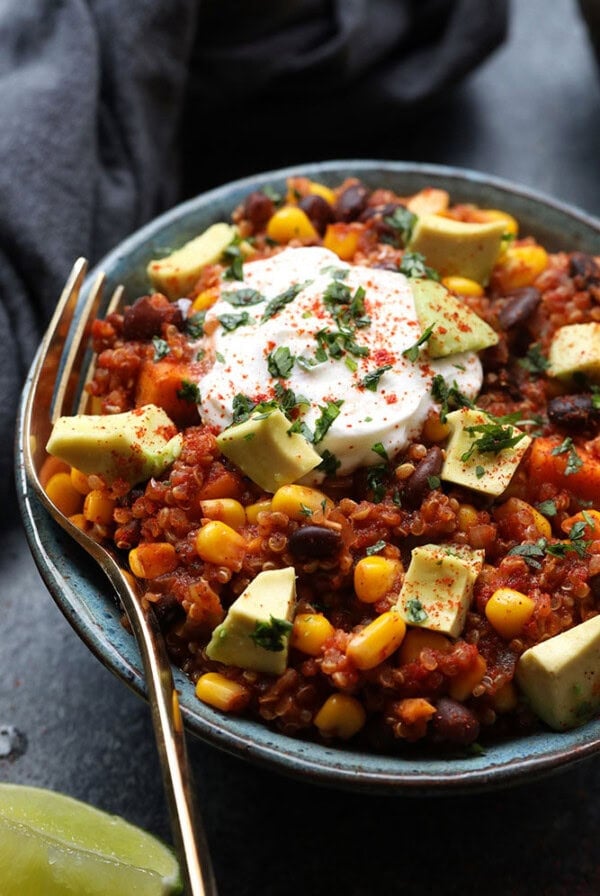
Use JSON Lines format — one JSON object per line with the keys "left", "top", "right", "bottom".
{"left": 0, "top": 0, "right": 600, "bottom": 896}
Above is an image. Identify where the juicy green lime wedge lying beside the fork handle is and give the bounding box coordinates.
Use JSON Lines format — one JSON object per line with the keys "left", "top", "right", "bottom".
{"left": 0, "top": 784, "right": 181, "bottom": 896}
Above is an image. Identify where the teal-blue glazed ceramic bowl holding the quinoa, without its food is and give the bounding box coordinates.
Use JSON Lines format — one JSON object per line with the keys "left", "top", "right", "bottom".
{"left": 17, "top": 161, "right": 600, "bottom": 795}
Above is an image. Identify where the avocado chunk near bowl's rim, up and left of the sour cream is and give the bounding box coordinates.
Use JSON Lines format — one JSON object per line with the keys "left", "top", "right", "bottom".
{"left": 147, "top": 222, "right": 237, "bottom": 299}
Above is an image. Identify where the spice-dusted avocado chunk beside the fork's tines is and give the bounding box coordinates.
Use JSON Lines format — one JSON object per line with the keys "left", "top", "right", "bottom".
{"left": 46, "top": 404, "right": 183, "bottom": 485}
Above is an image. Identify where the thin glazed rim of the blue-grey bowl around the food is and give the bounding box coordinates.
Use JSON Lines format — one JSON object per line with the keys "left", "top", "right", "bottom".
{"left": 15, "top": 159, "right": 600, "bottom": 795}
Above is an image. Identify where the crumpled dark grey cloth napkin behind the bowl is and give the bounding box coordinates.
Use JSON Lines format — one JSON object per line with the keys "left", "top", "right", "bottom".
{"left": 0, "top": 0, "right": 507, "bottom": 508}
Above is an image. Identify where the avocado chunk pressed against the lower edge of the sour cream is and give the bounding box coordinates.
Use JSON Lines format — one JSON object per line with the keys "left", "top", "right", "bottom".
{"left": 217, "top": 408, "right": 321, "bottom": 492}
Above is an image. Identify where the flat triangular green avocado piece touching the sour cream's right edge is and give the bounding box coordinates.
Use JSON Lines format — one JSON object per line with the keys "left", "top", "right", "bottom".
{"left": 409, "top": 279, "right": 498, "bottom": 358}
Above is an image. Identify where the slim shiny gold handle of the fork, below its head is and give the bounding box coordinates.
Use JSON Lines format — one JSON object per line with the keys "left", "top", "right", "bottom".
{"left": 110, "top": 568, "right": 217, "bottom": 896}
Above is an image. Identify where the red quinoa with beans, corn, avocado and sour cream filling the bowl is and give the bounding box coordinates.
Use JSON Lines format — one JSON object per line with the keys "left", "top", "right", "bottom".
{"left": 44, "top": 177, "right": 600, "bottom": 751}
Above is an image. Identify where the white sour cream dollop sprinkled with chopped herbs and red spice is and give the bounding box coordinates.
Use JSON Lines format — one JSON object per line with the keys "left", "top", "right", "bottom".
{"left": 199, "top": 247, "right": 482, "bottom": 481}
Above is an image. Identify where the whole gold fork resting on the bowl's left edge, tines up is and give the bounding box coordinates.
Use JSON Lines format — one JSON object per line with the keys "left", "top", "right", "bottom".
{"left": 20, "top": 258, "right": 217, "bottom": 896}
